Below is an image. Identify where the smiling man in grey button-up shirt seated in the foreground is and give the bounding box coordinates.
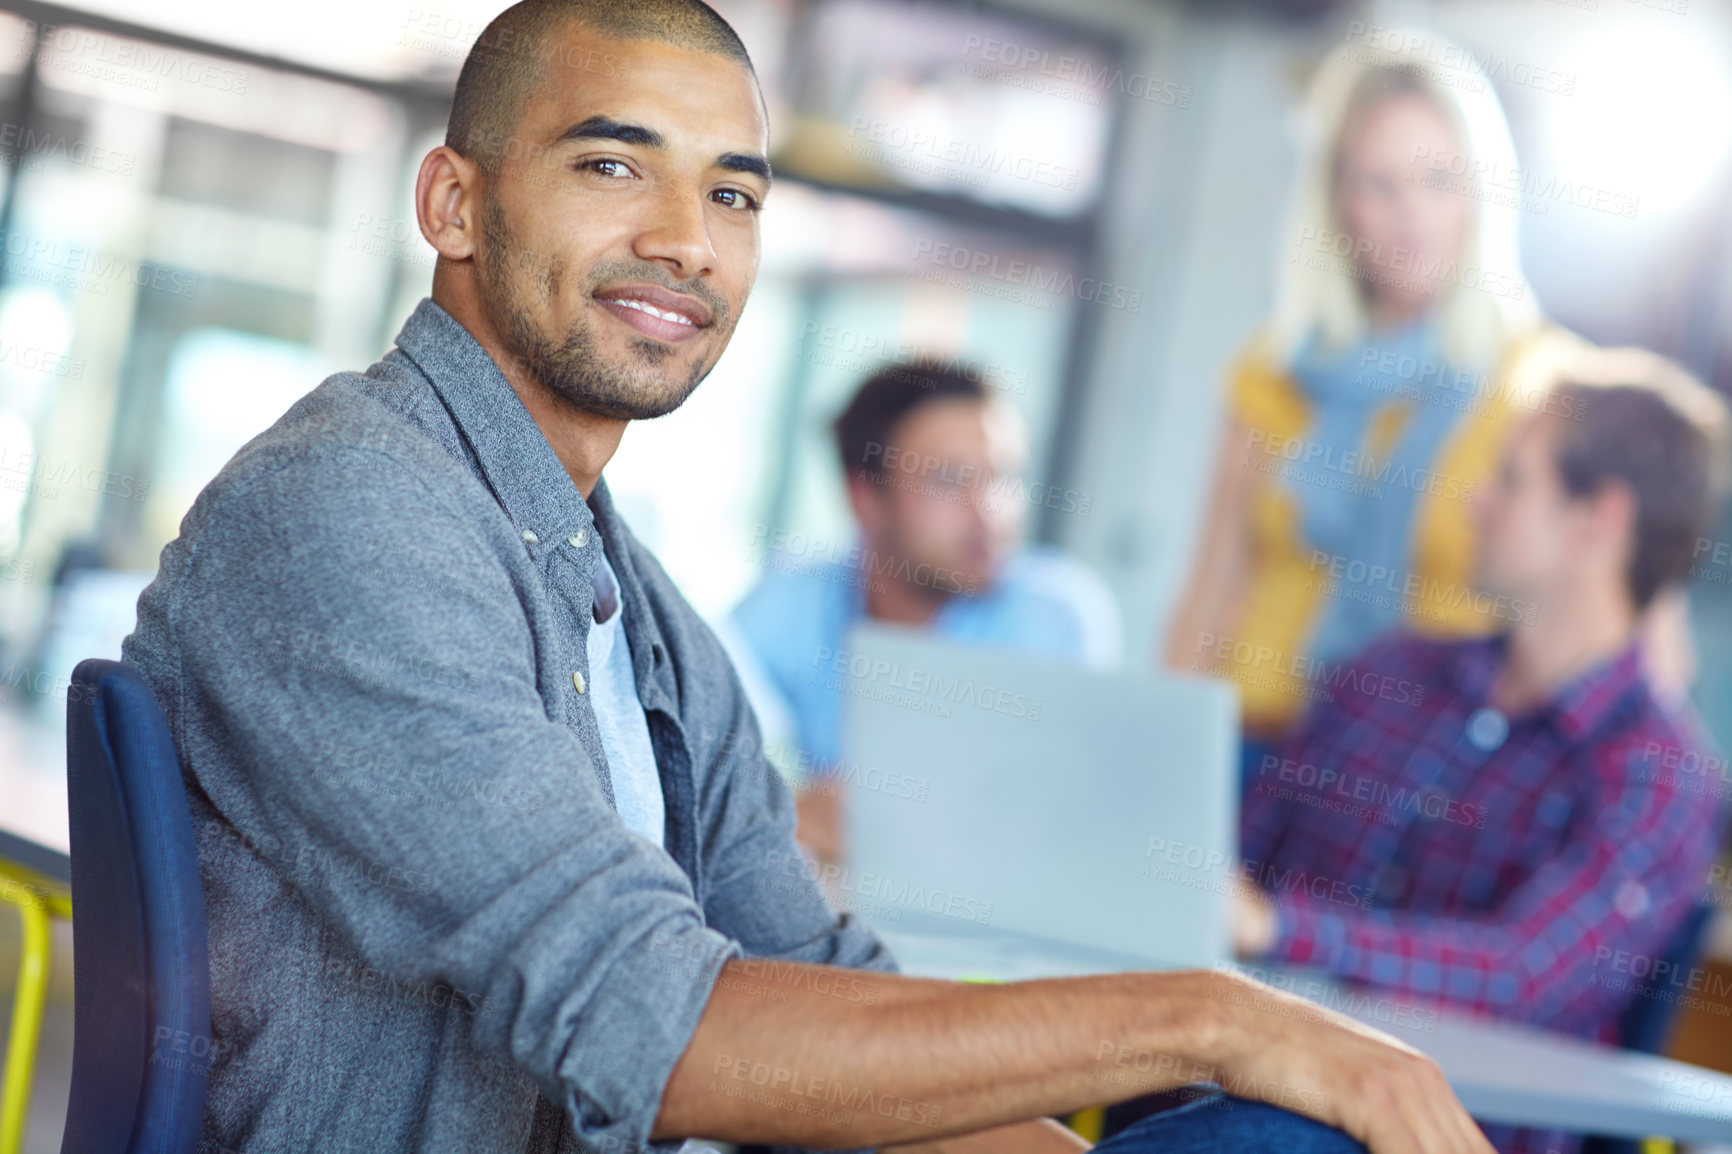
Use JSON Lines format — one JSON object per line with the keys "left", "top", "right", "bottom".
{"left": 125, "top": 0, "right": 1484, "bottom": 1154}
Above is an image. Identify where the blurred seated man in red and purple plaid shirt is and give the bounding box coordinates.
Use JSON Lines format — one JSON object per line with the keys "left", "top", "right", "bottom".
{"left": 1235, "top": 350, "right": 1727, "bottom": 1151}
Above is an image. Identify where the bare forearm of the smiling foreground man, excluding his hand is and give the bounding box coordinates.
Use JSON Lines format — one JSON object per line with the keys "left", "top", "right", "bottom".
{"left": 653, "top": 962, "right": 1212, "bottom": 1147}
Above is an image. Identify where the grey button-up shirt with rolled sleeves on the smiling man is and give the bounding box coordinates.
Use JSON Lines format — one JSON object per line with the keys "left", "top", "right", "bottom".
{"left": 123, "top": 300, "right": 895, "bottom": 1154}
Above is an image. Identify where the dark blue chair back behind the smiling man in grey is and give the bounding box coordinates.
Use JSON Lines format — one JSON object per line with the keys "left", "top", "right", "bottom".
{"left": 61, "top": 660, "right": 211, "bottom": 1154}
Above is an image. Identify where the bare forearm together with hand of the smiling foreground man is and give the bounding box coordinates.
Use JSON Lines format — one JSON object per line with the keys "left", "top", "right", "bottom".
{"left": 651, "top": 958, "right": 1491, "bottom": 1154}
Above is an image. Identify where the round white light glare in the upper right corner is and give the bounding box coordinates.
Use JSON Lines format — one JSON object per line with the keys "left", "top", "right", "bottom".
{"left": 1552, "top": 28, "right": 1732, "bottom": 217}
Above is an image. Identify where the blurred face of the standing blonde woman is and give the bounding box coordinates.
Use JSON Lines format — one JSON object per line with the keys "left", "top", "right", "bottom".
{"left": 1335, "top": 95, "right": 1474, "bottom": 312}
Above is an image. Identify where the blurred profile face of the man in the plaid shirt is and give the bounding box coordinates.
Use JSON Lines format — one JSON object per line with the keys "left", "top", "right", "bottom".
{"left": 1474, "top": 412, "right": 1592, "bottom": 610}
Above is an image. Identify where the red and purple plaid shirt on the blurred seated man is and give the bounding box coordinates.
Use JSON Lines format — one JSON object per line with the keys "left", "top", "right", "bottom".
{"left": 1240, "top": 629, "right": 1725, "bottom": 1149}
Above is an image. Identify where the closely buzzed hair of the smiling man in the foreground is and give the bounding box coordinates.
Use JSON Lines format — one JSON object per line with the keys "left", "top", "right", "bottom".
{"left": 445, "top": 0, "right": 757, "bottom": 175}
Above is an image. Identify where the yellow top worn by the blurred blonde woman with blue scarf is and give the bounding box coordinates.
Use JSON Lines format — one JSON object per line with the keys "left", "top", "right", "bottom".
{"left": 1219, "top": 327, "right": 1581, "bottom": 736}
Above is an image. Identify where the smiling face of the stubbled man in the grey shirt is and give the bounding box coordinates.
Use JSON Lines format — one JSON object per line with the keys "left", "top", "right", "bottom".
{"left": 476, "top": 28, "right": 769, "bottom": 419}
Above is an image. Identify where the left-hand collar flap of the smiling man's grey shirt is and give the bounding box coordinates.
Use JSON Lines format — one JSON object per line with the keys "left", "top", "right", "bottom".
{"left": 397, "top": 296, "right": 601, "bottom": 544}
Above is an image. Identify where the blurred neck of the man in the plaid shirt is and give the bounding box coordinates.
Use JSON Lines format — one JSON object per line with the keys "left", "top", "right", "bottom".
{"left": 1491, "top": 586, "right": 1635, "bottom": 716}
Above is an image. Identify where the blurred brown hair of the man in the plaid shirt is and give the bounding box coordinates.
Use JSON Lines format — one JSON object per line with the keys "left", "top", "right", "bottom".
{"left": 1552, "top": 348, "right": 1729, "bottom": 610}
